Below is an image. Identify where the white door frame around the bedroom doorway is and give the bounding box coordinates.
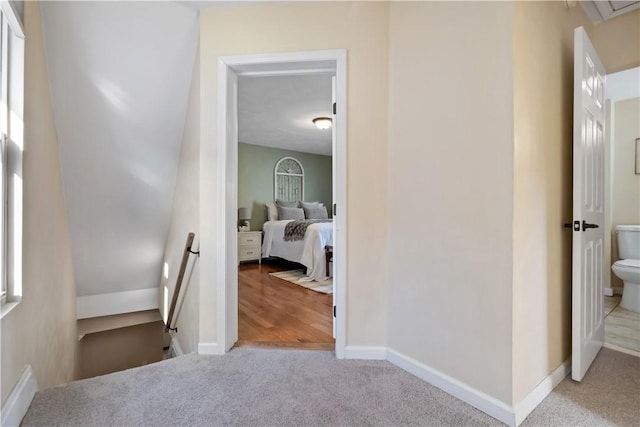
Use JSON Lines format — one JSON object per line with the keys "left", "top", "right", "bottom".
{"left": 213, "top": 49, "right": 348, "bottom": 359}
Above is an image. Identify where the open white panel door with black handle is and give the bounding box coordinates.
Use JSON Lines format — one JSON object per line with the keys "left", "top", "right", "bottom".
{"left": 571, "top": 27, "right": 606, "bottom": 381}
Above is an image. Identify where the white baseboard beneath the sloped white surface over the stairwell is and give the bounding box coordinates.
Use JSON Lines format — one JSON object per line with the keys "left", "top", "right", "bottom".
{"left": 76, "top": 288, "right": 160, "bottom": 319}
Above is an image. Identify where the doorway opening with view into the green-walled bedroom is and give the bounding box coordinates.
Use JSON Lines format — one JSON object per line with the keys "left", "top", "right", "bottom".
{"left": 235, "top": 71, "right": 335, "bottom": 350}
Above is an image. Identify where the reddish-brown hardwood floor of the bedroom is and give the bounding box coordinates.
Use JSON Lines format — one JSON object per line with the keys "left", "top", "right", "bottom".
{"left": 236, "top": 262, "right": 334, "bottom": 350}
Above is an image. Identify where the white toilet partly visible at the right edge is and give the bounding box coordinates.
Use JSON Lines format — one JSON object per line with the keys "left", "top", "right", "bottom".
{"left": 611, "top": 225, "right": 640, "bottom": 313}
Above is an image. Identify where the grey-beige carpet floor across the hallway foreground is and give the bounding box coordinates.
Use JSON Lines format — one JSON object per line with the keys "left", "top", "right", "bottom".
{"left": 22, "top": 348, "right": 640, "bottom": 426}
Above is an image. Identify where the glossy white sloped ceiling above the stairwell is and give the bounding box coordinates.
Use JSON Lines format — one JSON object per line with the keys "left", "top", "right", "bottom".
{"left": 41, "top": 1, "right": 198, "bottom": 296}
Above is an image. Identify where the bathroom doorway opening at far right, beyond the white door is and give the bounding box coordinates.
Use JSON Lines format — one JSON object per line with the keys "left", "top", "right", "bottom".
{"left": 603, "top": 67, "right": 640, "bottom": 356}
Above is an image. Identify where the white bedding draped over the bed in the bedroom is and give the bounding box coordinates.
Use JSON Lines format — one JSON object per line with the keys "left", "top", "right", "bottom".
{"left": 262, "top": 220, "right": 333, "bottom": 280}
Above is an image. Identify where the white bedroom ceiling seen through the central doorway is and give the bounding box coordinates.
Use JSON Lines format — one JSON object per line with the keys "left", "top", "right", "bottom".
{"left": 238, "top": 73, "right": 332, "bottom": 156}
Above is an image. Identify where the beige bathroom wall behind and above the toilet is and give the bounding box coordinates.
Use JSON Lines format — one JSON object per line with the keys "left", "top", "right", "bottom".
{"left": 611, "top": 98, "right": 640, "bottom": 280}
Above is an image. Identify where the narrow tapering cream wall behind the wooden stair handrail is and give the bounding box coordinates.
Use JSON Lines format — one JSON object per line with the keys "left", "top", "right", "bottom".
{"left": 160, "top": 49, "right": 200, "bottom": 353}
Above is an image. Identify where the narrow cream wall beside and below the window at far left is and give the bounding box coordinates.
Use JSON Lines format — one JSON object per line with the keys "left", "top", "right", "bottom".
{"left": 1, "top": 2, "right": 77, "bottom": 406}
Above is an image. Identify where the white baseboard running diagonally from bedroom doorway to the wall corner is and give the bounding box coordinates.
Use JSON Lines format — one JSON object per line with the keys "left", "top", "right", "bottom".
{"left": 387, "top": 349, "right": 515, "bottom": 425}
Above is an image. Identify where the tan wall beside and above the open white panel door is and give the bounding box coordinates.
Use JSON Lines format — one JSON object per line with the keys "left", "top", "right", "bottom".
{"left": 513, "top": 2, "right": 640, "bottom": 404}
